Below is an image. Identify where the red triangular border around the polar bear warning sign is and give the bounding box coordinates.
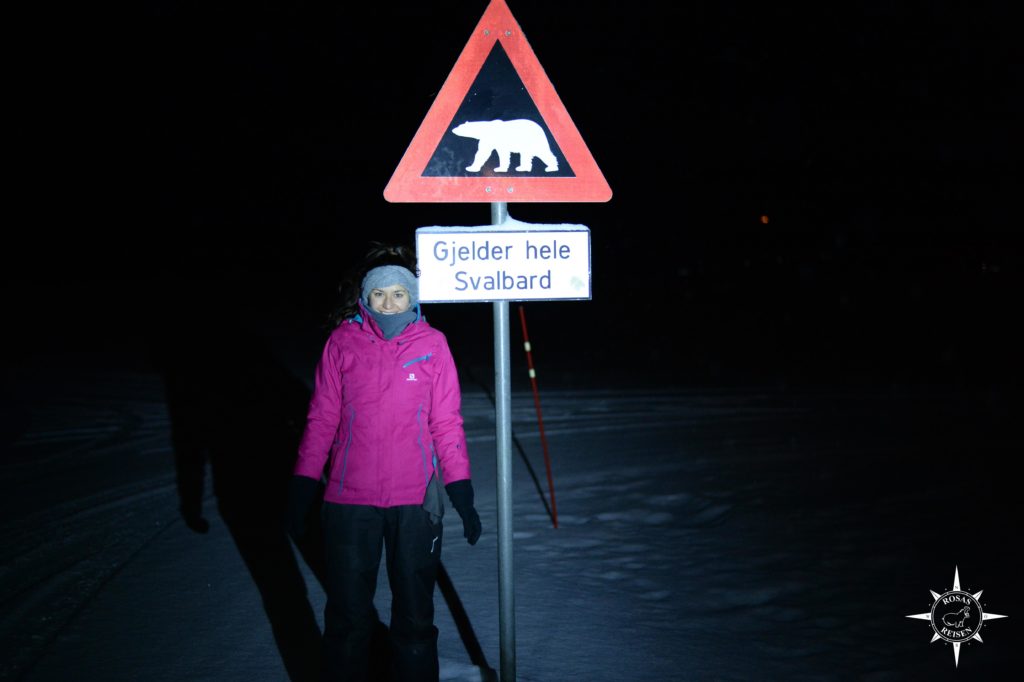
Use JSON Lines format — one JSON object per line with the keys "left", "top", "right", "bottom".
{"left": 384, "top": 0, "right": 611, "bottom": 203}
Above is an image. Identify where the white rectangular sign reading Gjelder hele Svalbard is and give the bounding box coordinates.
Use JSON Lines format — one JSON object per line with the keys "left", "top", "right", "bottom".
{"left": 416, "top": 218, "right": 591, "bottom": 303}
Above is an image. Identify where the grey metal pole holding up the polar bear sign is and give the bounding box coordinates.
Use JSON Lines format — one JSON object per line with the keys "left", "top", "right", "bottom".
{"left": 490, "top": 202, "right": 515, "bottom": 682}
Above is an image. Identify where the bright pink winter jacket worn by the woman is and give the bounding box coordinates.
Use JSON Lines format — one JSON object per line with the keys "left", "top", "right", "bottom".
{"left": 294, "top": 313, "right": 470, "bottom": 507}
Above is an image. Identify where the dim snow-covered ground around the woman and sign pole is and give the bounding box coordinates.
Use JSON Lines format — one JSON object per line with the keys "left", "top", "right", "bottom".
{"left": 0, "top": 352, "right": 1024, "bottom": 682}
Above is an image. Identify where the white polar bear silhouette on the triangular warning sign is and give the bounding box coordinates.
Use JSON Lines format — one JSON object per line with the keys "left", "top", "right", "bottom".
{"left": 452, "top": 119, "right": 558, "bottom": 173}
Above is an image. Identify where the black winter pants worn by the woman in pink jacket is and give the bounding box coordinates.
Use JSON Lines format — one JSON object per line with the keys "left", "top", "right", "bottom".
{"left": 324, "top": 503, "right": 441, "bottom": 682}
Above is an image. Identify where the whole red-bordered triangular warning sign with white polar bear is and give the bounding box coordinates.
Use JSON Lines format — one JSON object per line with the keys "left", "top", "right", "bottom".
{"left": 384, "top": 0, "right": 611, "bottom": 203}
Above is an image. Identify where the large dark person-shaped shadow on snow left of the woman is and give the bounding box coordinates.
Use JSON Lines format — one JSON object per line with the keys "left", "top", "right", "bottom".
{"left": 148, "top": 284, "right": 324, "bottom": 681}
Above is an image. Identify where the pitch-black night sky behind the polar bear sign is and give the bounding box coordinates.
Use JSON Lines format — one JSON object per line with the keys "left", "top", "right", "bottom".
{"left": 8, "top": 0, "right": 1022, "bottom": 384}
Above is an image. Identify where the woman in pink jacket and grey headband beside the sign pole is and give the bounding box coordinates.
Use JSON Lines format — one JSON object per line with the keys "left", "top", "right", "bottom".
{"left": 289, "top": 248, "right": 480, "bottom": 682}
